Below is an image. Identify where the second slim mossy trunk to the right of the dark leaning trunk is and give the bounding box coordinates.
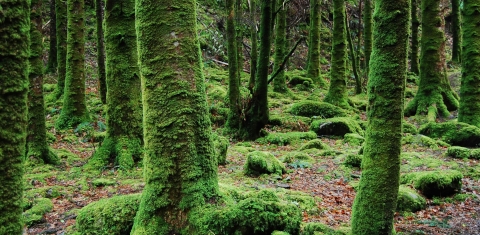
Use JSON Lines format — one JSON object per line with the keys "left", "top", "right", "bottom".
{"left": 307, "top": 0, "right": 327, "bottom": 87}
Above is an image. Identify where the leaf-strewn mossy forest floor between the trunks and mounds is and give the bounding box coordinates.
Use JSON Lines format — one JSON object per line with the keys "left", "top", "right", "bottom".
{"left": 25, "top": 65, "right": 480, "bottom": 235}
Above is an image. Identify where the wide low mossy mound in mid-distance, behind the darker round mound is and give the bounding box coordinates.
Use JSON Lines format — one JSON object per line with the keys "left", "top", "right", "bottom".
{"left": 289, "top": 100, "right": 348, "bottom": 118}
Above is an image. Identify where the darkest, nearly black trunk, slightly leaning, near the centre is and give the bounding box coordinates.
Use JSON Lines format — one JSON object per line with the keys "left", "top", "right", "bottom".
{"left": 239, "top": 0, "right": 272, "bottom": 139}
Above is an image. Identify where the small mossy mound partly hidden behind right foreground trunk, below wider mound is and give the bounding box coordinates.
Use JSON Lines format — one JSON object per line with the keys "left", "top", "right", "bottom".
{"left": 397, "top": 185, "right": 427, "bottom": 212}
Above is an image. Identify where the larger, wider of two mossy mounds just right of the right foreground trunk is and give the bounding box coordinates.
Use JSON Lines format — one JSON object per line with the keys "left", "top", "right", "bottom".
{"left": 400, "top": 170, "right": 463, "bottom": 198}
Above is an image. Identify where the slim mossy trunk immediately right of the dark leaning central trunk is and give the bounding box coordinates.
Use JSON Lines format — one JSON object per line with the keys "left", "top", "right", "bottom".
{"left": 273, "top": 0, "right": 288, "bottom": 93}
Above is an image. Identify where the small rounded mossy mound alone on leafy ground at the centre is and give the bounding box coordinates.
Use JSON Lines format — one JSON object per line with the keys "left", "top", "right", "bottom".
{"left": 243, "top": 151, "right": 286, "bottom": 175}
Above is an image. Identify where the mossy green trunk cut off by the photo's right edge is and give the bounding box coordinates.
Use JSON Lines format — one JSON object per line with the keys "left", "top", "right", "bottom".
{"left": 458, "top": 0, "right": 480, "bottom": 127}
